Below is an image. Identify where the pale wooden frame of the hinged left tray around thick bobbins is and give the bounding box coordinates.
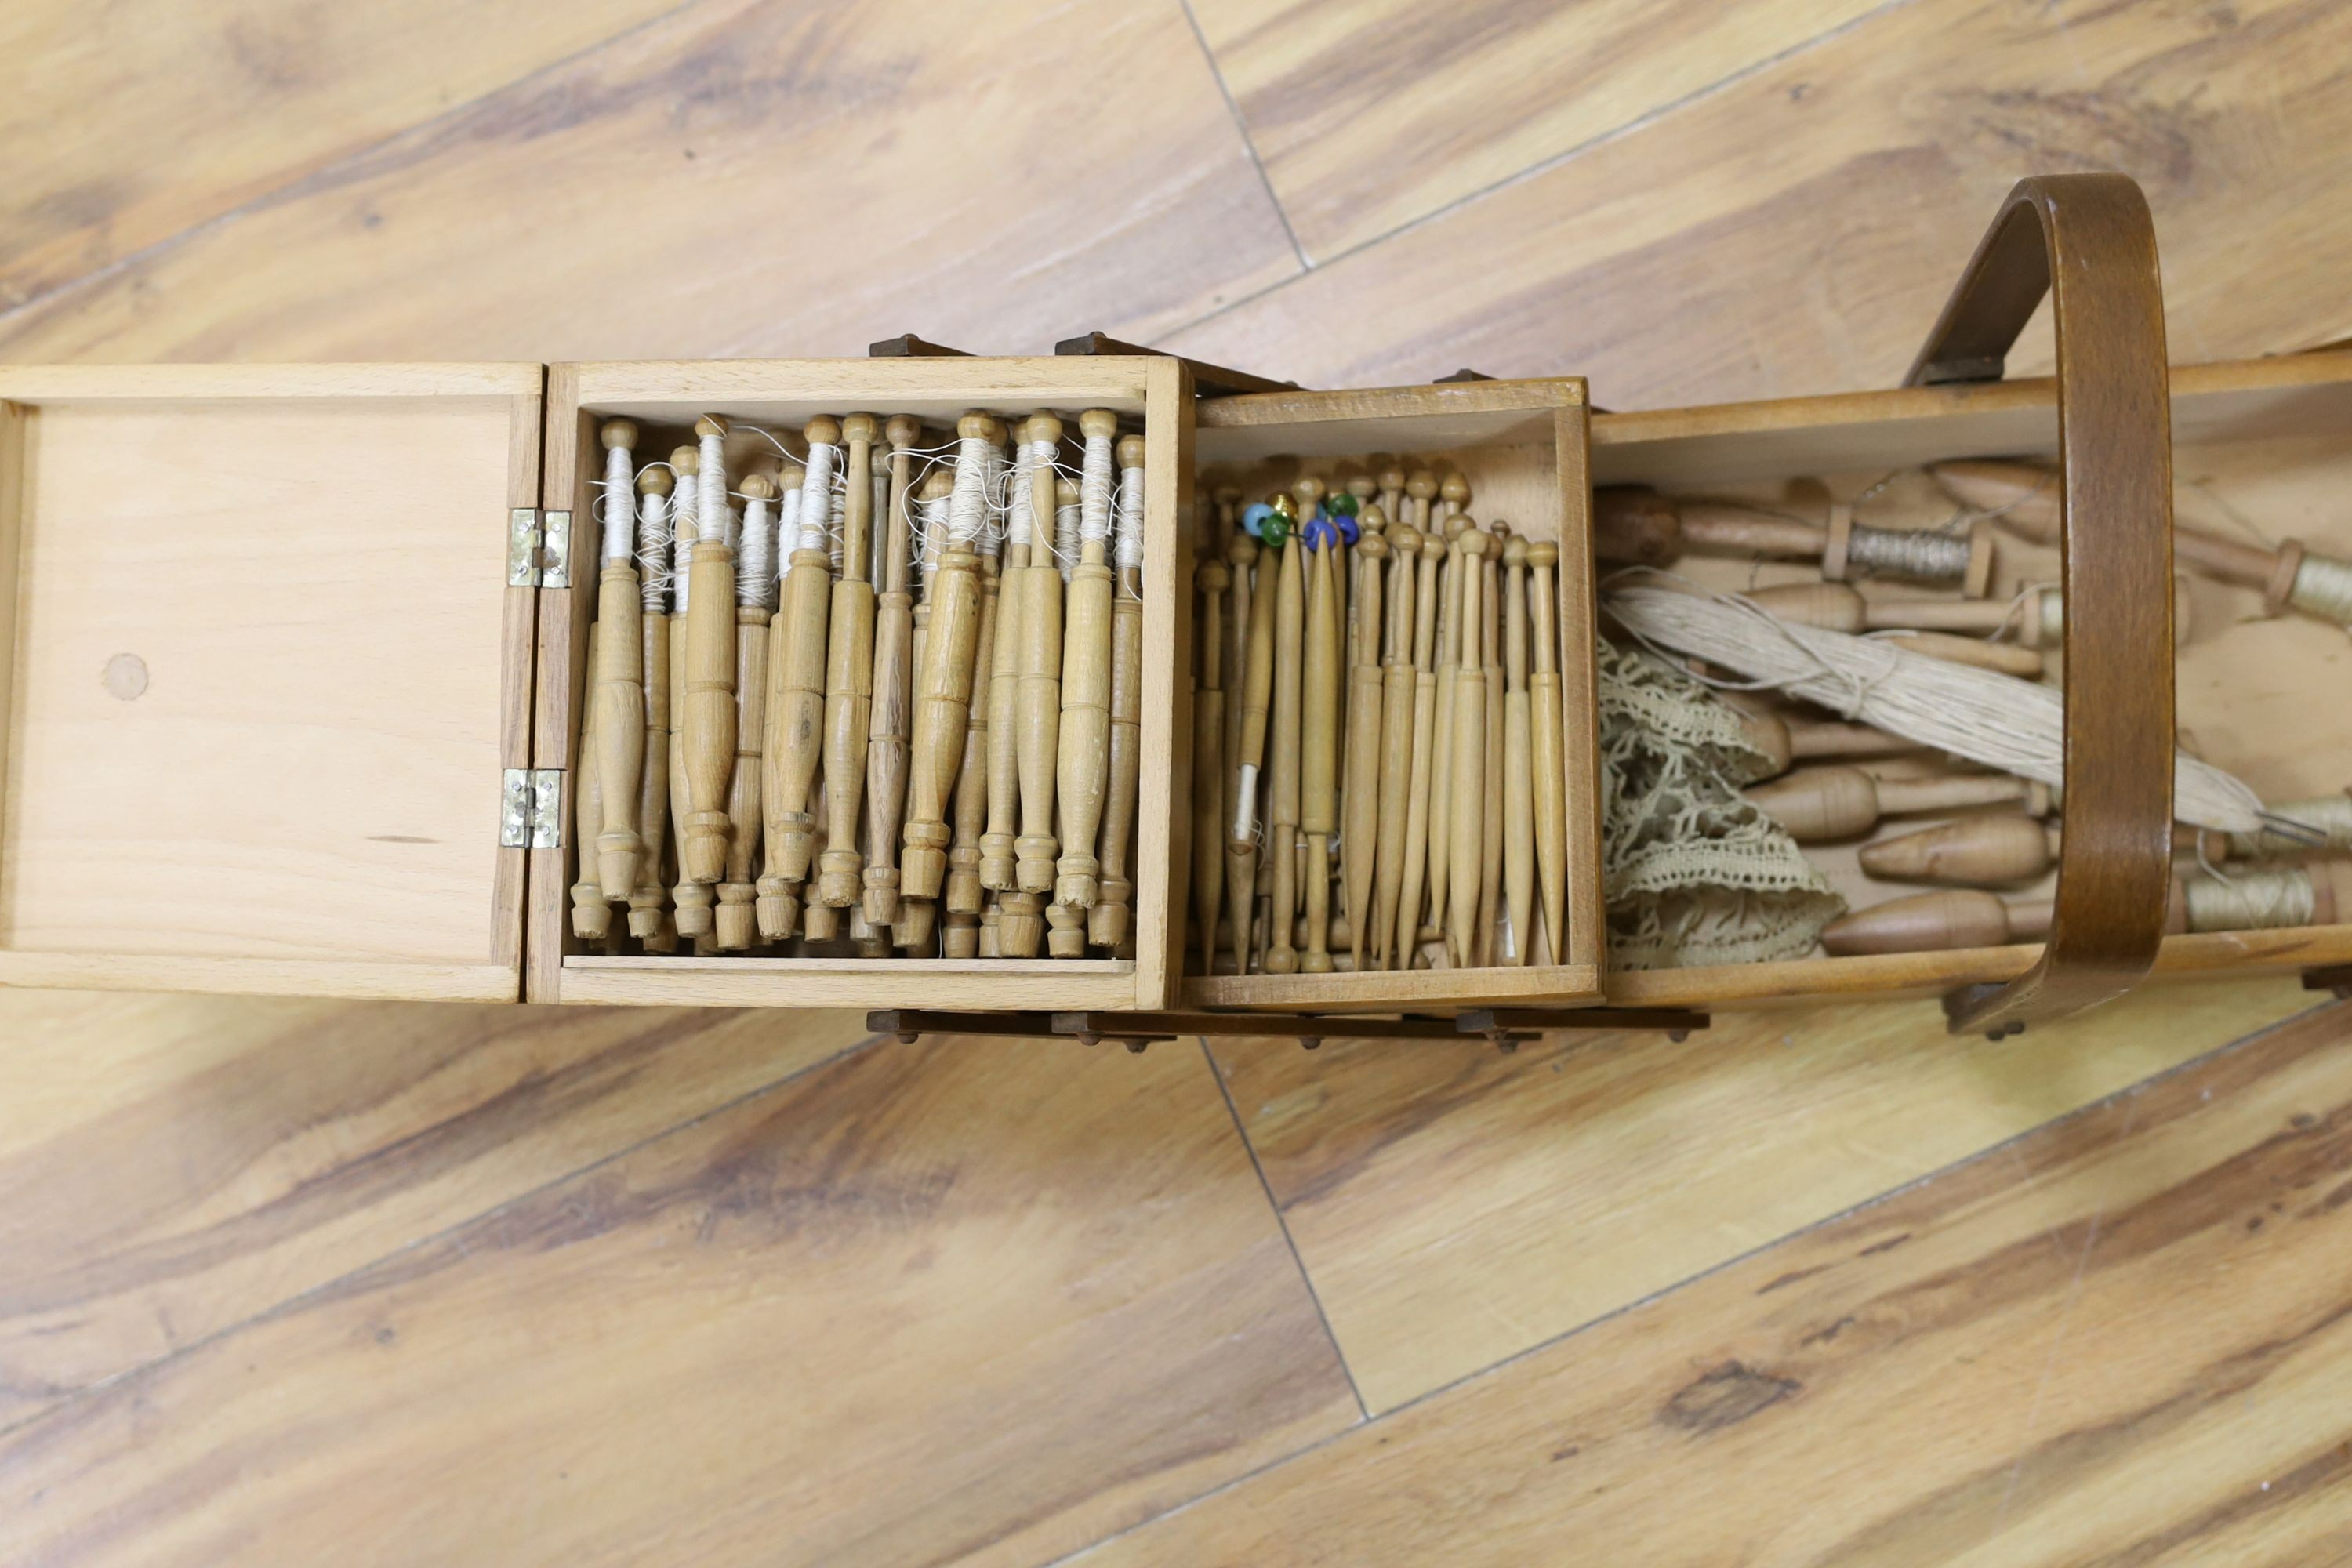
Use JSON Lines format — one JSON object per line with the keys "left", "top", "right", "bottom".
{"left": 539, "top": 355, "right": 1192, "bottom": 1011}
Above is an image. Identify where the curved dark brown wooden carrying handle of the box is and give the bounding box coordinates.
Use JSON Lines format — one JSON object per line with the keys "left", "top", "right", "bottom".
{"left": 1903, "top": 174, "right": 2173, "bottom": 1034}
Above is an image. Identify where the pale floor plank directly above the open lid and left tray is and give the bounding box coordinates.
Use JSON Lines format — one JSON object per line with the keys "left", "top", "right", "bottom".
{"left": 0, "top": 0, "right": 1298, "bottom": 362}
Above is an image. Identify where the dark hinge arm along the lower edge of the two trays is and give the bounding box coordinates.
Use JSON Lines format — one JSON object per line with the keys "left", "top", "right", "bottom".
{"left": 866, "top": 1006, "right": 1708, "bottom": 1051}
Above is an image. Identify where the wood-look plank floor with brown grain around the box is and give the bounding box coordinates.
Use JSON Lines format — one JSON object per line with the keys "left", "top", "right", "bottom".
{"left": 0, "top": 0, "right": 2352, "bottom": 1568}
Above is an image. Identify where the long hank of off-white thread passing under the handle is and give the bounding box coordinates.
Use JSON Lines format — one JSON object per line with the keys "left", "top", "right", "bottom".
{"left": 1609, "top": 569, "right": 2263, "bottom": 832}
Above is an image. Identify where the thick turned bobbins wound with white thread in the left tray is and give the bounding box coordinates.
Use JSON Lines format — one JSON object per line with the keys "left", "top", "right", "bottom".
{"left": 572, "top": 409, "right": 1145, "bottom": 959}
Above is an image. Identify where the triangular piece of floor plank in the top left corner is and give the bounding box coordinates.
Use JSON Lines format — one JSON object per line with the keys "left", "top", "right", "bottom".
{"left": 0, "top": 0, "right": 680, "bottom": 308}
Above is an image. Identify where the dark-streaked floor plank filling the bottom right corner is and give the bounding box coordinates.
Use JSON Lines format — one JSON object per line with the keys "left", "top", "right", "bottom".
{"left": 1084, "top": 1006, "right": 2352, "bottom": 1568}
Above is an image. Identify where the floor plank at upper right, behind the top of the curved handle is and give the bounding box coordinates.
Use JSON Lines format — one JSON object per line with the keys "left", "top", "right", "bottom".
{"left": 1164, "top": 0, "right": 2352, "bottom": 409}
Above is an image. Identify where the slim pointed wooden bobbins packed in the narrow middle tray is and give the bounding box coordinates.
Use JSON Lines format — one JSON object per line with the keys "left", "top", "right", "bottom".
{"left": 1188, "top": 461, "right": 1569, "bottom": 975}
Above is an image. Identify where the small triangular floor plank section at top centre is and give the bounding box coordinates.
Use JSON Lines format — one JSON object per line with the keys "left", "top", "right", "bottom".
{"left": 1192, "top": 0, "right": 1879, "bottom": 261}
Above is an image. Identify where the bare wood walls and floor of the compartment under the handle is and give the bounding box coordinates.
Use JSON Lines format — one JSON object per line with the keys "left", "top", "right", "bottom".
{"left": 1592, "top": 353, "right": 2352, "bottom": 1006}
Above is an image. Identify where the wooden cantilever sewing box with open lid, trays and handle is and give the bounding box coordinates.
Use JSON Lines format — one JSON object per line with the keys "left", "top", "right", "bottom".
{"left": 0, "top": 176, "right": 2352, "bottom": 1041}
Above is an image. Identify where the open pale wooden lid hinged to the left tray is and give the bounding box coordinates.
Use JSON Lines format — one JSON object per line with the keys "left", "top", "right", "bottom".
{"left": 0, "top": 365, "right": 546, "bottom": 999}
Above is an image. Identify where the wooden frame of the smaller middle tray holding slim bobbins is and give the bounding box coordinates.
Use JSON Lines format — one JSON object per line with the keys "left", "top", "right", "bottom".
{"left": 1183, "top": 379, "right": 1604, "bottom": 1013}
